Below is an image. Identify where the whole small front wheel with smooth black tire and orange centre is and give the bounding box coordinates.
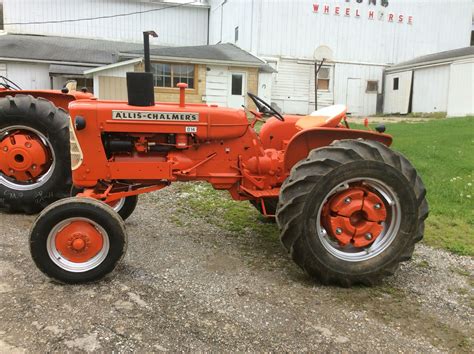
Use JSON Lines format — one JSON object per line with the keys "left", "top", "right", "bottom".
{"left": 30, "top": 198, "right": 127, "bottom": 283}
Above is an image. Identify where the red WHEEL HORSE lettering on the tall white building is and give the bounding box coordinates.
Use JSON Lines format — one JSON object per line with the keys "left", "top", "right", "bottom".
{"left": 313, "top": 0, "right": 413, "bottom": 25}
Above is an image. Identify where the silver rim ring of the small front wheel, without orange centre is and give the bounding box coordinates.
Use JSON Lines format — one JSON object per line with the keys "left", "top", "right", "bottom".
{"left": 46, "top": 218, "right": 110, "bottom": 273}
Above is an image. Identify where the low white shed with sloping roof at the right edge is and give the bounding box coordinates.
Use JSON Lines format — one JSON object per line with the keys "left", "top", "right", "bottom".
{"left": 384, "top": 46, "right": 474, "bottom": 117}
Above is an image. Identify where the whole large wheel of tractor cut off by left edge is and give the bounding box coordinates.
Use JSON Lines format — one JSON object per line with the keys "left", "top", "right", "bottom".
{"left": 0, "top": 95, "right": 71, "bottom": 214}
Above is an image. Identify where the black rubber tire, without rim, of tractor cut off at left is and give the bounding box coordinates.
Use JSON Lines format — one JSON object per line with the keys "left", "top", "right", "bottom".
{"left": 0, "top": 95, "right": 71, "bottom": 214}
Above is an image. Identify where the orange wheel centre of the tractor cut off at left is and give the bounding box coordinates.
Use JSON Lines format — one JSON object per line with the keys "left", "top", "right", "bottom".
{"left": 0, "top": 131, "right": 50, "bottom": 182}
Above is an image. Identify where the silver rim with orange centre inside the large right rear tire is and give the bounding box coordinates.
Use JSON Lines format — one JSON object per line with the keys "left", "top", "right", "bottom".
{"left": 315, "top": 177, "right": 402, "bottom": 262}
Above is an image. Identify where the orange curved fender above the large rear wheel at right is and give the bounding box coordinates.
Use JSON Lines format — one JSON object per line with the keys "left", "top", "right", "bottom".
{"left": 284, "top": 127, "right": 392, "bottom": 171}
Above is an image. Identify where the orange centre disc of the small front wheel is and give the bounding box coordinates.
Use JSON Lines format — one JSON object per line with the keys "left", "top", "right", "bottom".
{"left": 55, "top": 221, "right": 104, "bottom": 263}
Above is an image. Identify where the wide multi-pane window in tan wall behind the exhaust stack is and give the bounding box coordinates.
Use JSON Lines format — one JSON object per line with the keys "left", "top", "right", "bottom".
{"left": 151, "top": 63, "right": 194, "bottom": 88}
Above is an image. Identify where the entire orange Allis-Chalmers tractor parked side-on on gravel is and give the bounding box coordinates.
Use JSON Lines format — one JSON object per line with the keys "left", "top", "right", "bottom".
{"left": 25, "top": 35, "right": 428, "bottom": 286}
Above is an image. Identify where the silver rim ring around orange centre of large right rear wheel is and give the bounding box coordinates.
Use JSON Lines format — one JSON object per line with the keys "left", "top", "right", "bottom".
{"left": 316, "top": 178, "right": 401, "bottom": 262}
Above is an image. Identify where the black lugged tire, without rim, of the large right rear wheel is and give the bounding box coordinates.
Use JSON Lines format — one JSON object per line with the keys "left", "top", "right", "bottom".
{"left": 276, "top": 140, "right": 428, "bottom": 287}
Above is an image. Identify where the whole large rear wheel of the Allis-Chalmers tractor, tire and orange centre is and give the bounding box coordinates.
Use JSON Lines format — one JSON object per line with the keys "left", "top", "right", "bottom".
{"left": 276, "top": 140, "right": 428, "bottom": 286}
